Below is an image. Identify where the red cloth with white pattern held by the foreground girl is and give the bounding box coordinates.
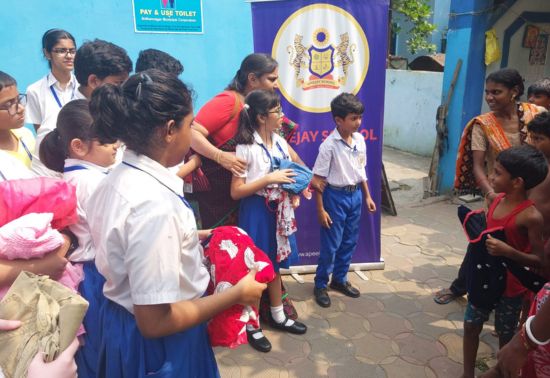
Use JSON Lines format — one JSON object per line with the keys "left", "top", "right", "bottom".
{"left": 204, "top": 226, "right": 275, "bottom": 348}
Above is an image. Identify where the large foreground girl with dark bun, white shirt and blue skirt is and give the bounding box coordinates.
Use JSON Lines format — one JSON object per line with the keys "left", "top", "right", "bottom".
{"left": 86, "top": 70, "right": 266, "bottom": 378}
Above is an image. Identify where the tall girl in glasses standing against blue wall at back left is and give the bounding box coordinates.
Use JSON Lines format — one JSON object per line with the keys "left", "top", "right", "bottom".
{"left": 25, "top": 29, "right": 83, "bottom": 151}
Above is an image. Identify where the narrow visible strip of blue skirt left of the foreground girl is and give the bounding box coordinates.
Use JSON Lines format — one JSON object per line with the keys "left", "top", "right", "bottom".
{"left": 75, "top": 261, "right": 107, "bottom": 378}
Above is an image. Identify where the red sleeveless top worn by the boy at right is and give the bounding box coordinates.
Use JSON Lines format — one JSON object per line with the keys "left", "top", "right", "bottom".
{"left": 487, "top": 194, "right": 534, "bottom": 297}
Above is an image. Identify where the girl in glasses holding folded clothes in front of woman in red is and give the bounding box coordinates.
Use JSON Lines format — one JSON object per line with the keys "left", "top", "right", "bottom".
{"left": 231, "top": 90, "right": 307, "bottom": 352}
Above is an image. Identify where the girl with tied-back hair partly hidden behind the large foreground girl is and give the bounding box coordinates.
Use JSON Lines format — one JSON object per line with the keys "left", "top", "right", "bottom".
{"left": 40, "top": 100, "right": 119, "bottom": 377}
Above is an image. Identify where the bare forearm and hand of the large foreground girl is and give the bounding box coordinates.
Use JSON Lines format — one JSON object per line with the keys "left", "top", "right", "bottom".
{"left": 134, "top": 270, "right": 267, "bottom": 338}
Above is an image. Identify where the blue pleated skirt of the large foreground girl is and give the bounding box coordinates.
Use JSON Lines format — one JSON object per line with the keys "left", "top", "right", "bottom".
{"left": 97, "top": 300, "right": 220, "bottom": 378}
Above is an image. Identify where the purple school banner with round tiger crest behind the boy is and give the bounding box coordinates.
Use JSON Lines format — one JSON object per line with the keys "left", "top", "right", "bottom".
{"left": 252, "top": 0, "right": 389, "bottom": 272}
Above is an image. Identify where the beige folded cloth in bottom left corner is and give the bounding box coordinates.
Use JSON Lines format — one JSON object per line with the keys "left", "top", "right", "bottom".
{"left": 0, "top": 272, "right": 88, "bottom": 378}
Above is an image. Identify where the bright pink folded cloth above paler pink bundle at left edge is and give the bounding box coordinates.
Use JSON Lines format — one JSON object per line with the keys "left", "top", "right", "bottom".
{"left": 0, "top": 177, "right": 78, "bottom": 230}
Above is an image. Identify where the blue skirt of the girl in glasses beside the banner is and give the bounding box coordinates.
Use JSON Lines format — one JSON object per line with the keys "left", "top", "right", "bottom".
{"left": 239, "top": 194, "right": 298, "bottom": 272}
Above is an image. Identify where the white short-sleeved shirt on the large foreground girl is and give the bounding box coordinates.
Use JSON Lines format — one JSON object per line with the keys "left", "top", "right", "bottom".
{"left": 86, "top": 149, "right": 210, "bottom": 313}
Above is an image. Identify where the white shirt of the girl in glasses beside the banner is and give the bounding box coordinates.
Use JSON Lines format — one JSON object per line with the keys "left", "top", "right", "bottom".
{"left": 236, "top": 131, "right": 290, "bottom": 193}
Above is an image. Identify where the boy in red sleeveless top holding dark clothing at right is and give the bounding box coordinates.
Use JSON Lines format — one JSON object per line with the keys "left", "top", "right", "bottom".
{"left": 463, "top": 145, "right": 548, "bottom": 377}
